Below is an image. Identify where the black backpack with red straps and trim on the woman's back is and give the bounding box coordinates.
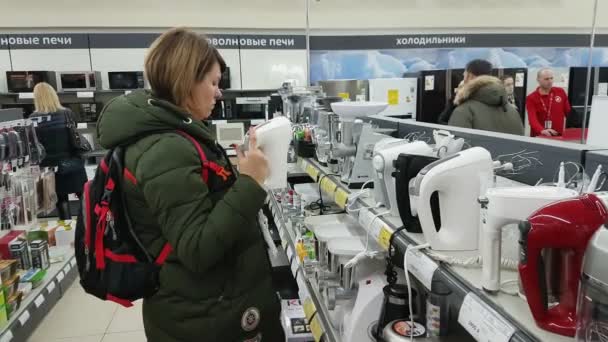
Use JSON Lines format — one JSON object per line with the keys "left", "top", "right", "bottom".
{"left": 75, "top": 131, "right": 224, "bottom": 307}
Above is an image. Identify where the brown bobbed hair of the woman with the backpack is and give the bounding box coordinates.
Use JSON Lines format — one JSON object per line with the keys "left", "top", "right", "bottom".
{"left": 145, "top": 28, "right": 226, "bottom": 107}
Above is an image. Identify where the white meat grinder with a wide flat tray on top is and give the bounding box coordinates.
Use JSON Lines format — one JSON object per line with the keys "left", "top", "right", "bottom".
{"left": 331, "top": 102, "right": 388, "bottom": 188}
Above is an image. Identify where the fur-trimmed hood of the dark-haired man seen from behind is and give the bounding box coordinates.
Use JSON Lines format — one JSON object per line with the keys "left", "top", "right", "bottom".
{"left": 455, "top": 76, "right": 507, "bottom": 108}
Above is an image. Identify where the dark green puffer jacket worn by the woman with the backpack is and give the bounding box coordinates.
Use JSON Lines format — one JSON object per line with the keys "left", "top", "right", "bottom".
{"left": 98, "top": 91, "right": 283, "bottom": 342}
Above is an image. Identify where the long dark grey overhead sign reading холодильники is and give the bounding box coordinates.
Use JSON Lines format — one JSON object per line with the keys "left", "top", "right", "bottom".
{"left": 310, "top": 34, "right": 608, "bottom": 50}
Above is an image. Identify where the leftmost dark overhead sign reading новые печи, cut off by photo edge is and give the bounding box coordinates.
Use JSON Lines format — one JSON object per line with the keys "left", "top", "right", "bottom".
{"left": 0, "top": 33, "right": 89, "bottom": 50}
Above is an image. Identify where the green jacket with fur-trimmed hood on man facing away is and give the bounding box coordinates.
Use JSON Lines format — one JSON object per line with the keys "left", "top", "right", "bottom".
{"left": 448, "top": 76, "right": 524, "bottom": 135}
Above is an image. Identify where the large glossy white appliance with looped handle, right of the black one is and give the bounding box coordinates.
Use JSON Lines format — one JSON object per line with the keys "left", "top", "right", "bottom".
{"left": 411, "top": 147, "right": 494, "bottom": 251}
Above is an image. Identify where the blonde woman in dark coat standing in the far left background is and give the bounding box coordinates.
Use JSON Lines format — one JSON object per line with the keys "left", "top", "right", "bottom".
{"left": 31, "top": 82, "right": 87, "bottom": 220}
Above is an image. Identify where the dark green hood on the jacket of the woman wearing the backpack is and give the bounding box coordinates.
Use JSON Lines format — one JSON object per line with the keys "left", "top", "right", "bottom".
{"left": 97, "top": 90, "right": 215, "bottom": 149}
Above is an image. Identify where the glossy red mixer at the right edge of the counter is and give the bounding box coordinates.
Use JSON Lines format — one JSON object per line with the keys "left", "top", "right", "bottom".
{"left": 519, "top": 193, "right": 608, "bottom": 336}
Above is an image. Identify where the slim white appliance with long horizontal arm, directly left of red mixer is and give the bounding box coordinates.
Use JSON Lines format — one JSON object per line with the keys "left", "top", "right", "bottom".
{"left": 479, "top": 186, "right": 578, "bottom": 293}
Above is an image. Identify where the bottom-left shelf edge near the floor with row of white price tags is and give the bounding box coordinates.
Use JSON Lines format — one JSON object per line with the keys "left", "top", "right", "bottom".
{"left": 0, "top": 251, "right": 78, "bottom": 342}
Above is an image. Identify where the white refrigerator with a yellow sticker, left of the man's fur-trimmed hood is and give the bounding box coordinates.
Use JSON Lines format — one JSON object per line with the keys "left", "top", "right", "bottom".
{"left": 369, "top": 77, "right": 418, "bottom": 119}
